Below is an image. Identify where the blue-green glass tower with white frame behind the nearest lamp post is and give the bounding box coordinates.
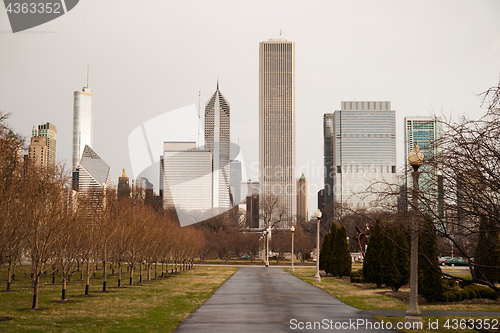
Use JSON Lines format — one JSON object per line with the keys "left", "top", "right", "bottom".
{"left": 404, "top": 116, "right": 444, "bottom": 216}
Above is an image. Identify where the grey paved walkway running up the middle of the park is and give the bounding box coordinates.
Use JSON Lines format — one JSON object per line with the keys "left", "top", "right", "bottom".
{"left": 176, "top": 267, "right": 396, "bottom": 333}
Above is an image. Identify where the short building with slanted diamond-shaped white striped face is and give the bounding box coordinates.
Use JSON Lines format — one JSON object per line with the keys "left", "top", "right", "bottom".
{"left": 73, "top": 145, "right": 113, "bottom": 192}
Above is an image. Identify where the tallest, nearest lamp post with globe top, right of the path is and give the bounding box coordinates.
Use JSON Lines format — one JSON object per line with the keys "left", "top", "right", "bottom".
{"left": 405, "top": 145, "right": 424, "bottom": 323}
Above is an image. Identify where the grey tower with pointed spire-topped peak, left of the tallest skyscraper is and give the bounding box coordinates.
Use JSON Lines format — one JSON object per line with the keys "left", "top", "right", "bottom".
{"left": 205, "top": 81, "right": 231, "bottom": 208}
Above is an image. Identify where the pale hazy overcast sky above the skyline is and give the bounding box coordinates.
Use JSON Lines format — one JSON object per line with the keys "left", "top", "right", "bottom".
{"left": 0, "top": 0, "right": 500, "bottom": 214}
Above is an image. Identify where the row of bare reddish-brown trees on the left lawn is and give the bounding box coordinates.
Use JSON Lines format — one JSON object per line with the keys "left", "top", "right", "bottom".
{"left": 0, "top": 114, "right": 204, "bottom": 308}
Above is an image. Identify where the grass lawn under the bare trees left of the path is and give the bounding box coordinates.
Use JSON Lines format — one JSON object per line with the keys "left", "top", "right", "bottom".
{"left": 0, "top": 267, "right": 237, "bottom": 332}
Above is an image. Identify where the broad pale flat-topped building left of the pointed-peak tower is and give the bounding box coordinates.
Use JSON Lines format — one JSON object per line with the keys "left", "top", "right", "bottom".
{"left": 163, "top": 141, "right": 213, "bottom": 211}
